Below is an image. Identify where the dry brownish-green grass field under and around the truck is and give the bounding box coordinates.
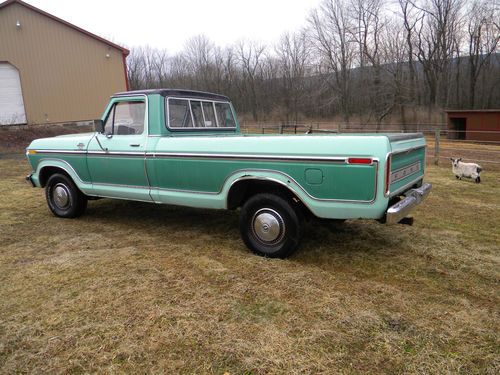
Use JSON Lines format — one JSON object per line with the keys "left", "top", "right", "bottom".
{"left": 0, "top": 155, "right": 500, "bottom": 374}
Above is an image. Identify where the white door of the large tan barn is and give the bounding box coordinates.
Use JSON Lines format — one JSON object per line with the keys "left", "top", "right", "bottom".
{"left": 0, "top": 62, "right": 26, "bottom": 125}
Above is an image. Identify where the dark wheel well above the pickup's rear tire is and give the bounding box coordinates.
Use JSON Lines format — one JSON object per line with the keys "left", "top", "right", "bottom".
{"left": 227, "top": 179, "right": 312, "bottom": 215}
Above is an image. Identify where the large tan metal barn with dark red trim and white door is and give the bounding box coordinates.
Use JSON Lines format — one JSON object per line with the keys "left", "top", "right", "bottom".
{"left": 0, "top": 0, "right": 129, "bottom": 125}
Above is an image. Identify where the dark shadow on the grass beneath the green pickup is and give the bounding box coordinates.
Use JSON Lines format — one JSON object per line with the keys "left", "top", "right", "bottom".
{"left": 82, "top": 199, "right": 397, "bottom": 260}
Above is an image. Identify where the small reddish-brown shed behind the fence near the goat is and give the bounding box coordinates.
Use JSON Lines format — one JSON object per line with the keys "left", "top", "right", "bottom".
{"left": 445, "top": 109, "right": 500, "bottom": 142}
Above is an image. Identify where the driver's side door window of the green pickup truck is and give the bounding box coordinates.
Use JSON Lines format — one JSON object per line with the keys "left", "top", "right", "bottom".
{"left": 104, "top": 101, "right": 146, "bottom": 135}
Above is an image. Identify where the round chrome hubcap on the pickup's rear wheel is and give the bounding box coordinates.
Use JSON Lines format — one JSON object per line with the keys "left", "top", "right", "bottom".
{"left": 252, "top": 208, "right": 285, "bottom": 244}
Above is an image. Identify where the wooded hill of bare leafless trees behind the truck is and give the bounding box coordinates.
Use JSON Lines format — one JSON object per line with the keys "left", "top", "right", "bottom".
{"left": 127, "top": 0, "right": 500, "bottom": 124}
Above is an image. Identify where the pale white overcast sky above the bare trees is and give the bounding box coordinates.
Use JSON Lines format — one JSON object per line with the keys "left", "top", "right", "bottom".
{"left": 23, "top": 0, "right": 320, "bottom": 54}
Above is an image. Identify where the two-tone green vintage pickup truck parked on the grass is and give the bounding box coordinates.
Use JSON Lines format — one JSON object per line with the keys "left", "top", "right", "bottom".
{"left": 26, "top": 89, "right": 431, "bottom": 258}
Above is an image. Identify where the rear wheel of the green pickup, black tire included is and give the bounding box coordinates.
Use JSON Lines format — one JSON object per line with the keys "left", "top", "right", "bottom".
{"left": 240, "top": 194, "right": 301, "bottom": 258}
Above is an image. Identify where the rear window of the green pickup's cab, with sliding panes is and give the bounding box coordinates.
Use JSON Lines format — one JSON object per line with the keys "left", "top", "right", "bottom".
{"left": 166, "top": 98, "right": 236, "bottom": 129}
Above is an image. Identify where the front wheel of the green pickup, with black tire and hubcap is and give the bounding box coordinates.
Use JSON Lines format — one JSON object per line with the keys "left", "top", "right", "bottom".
{"left": 45, "top": 173, "right": 87, "bottom": 218}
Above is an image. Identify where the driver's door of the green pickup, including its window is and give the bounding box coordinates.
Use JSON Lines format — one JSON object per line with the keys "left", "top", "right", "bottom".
{"left": 87, "top": 96, "right": 151, "bottom": 201}
